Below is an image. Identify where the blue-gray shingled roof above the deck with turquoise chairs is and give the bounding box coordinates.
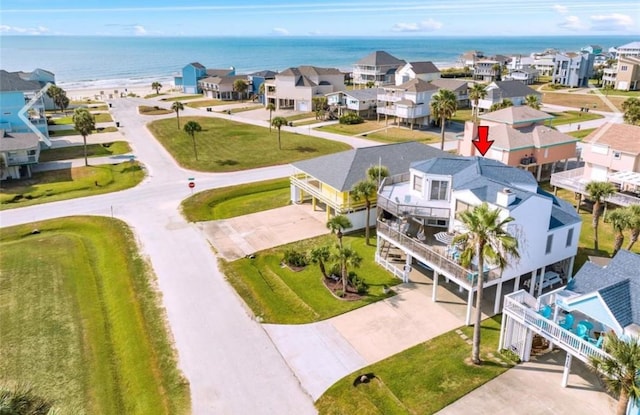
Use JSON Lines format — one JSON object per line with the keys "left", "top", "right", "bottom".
{"left": 571, "top": 249, "right": 640, "bottom": 327}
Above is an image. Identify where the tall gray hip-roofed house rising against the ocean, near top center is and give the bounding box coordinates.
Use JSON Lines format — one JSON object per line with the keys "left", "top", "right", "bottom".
{"left": 352, "top": 50, "right": 406, "bottom": 87}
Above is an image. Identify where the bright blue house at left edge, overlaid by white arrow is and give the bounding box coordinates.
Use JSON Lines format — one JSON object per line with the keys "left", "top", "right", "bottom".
{"left": 0, "top": 70, "right": 52, "bottom": 146}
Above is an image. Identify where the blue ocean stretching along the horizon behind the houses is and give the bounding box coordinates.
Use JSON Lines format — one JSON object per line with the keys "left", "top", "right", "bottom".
{"left": 0, "top": 36, "right": 638, "bottom": 89}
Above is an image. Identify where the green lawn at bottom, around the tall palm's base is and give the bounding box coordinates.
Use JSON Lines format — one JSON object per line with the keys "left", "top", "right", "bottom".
{"left": 316, "top": 316, "right": 516, "bottom": 415}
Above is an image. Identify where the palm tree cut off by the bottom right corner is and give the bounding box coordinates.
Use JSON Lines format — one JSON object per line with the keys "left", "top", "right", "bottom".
{"left": 589, "top": 333, "right": 640, "bottom": 415}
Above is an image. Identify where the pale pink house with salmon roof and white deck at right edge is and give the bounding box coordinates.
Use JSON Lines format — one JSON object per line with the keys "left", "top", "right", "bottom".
{"left": 551, "top": 123, "right": 640, "bottom": 206}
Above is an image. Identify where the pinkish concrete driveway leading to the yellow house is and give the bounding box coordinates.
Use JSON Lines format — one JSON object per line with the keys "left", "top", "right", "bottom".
{"left": 197, "top": 204, "right": 329, "bottom": 260}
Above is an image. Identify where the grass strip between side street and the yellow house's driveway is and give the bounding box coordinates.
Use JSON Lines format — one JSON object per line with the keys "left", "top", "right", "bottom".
{"left": 182, "top": 178, "right": 291, "bottom": 222}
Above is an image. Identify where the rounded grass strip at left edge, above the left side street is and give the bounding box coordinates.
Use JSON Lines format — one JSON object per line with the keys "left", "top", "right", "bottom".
{"left": 0, "top": 161, "right": 145, "bottom": 210}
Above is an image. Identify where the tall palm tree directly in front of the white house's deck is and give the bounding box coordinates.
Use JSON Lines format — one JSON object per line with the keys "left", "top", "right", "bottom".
{"left": 453, "top": 203, "right": 520, "bottom": 364}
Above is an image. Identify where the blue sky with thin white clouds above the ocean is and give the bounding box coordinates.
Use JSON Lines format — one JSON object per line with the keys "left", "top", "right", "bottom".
{"left": 0, "top": 0, "right": 640, "bottom": 36}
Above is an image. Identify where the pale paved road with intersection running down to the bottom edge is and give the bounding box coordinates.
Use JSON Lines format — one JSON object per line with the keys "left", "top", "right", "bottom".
{"left": 0, "top": 99, "right": 316, "bottom": 414}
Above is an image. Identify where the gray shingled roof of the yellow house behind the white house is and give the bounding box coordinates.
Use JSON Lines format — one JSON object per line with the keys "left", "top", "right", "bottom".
{"left": 292, "top": 142, "right": 448, "bottom": 192}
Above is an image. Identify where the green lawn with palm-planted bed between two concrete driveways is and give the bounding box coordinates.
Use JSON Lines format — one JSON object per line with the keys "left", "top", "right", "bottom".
{"left": 222, "top": 234, "right": 400, "bottom": 324}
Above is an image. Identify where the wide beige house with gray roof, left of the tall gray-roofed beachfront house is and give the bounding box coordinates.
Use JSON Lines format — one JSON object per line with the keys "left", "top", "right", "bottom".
{"left": 264, "top": 65, "right": 346, "bottom": 112}
